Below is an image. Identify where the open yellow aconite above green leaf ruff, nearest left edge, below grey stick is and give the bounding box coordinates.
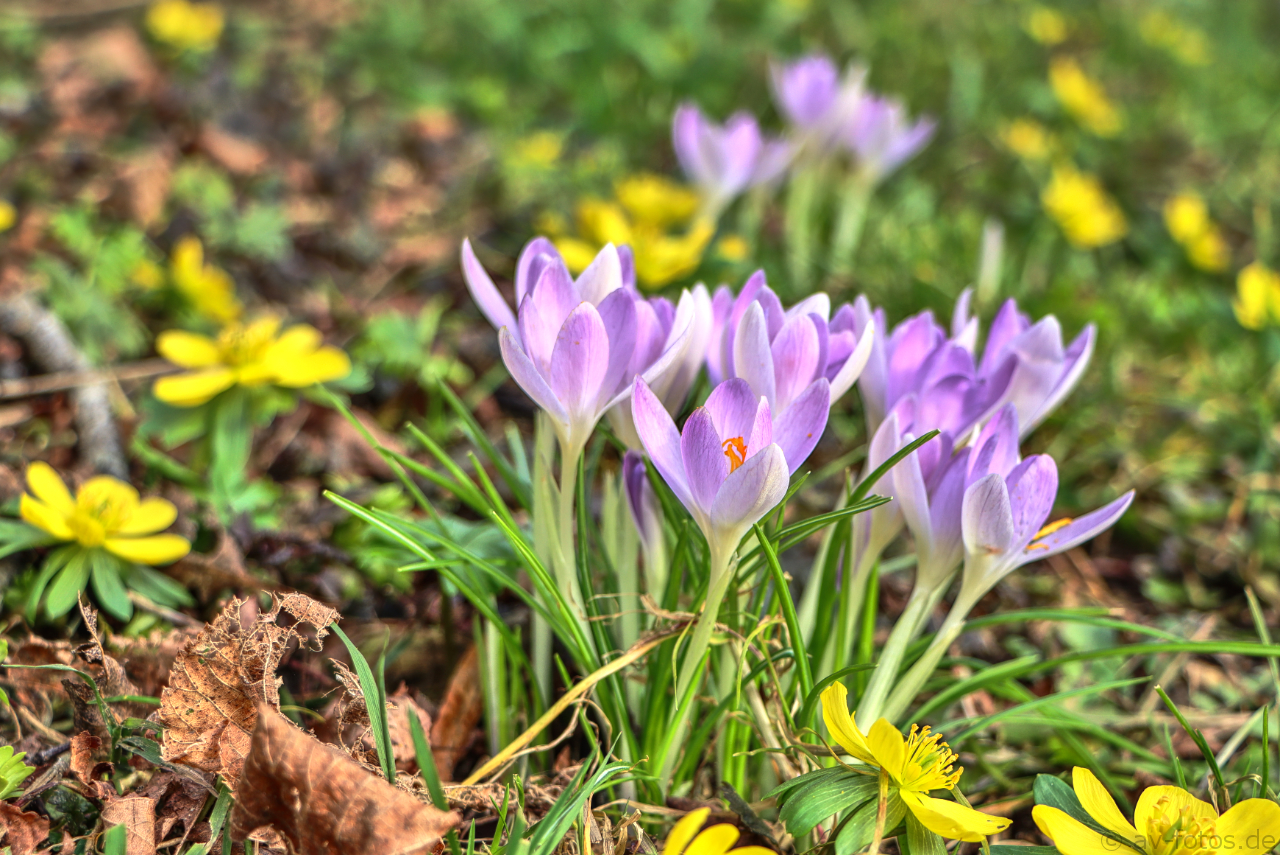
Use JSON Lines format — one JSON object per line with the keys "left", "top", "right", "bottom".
{"left": 19, "top": 461, "right": 191, "bottom": 564}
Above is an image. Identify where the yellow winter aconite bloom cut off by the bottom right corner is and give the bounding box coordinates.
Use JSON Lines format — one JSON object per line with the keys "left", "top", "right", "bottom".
{"left": 1032, "top": 767, "right": 1280, "bottom": 855}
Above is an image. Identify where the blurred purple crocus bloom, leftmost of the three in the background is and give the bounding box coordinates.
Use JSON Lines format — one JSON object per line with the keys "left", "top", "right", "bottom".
{"left": 672, "top": 104, "right": 791, "bottom": 215}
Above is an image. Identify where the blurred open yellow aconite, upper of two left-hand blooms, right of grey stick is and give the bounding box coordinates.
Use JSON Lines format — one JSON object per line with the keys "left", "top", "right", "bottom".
{"left": 155, "top": 317, "right": 351, "bottom": 407}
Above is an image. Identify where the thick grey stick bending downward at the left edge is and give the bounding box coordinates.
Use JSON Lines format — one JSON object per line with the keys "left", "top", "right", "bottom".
{"left": 0, "top": 294, "right": 128, "bottom": 479}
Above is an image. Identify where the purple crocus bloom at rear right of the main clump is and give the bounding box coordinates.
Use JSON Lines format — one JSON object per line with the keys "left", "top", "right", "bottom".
{"left": 951, "top": 291, "right": 1097, "bottom": 436}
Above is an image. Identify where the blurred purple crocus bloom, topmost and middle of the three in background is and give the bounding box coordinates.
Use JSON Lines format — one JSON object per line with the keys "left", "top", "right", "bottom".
{"left": 769, "top": 54, "right": 867, "bottom": 148}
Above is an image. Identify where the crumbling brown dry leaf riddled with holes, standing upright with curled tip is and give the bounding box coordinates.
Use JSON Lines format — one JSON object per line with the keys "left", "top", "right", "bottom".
{"left": 159, "top": 594, "right": 338, "bottom": 787}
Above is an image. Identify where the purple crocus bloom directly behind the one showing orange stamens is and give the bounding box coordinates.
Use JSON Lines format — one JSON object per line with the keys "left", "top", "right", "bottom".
{"left": 707, "top": 270, "right": 874, "bottom": 471}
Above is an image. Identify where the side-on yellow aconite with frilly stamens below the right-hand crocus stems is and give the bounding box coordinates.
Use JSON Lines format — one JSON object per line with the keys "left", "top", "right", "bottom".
{"left": 822, "top": 682, "right": 1010, "bottom": 842}
